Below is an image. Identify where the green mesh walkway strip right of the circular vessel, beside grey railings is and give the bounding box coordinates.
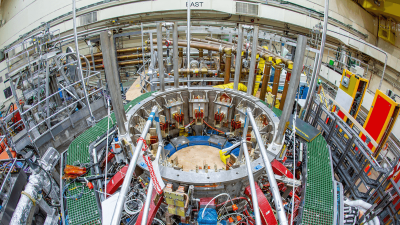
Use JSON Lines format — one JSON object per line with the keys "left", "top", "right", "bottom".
{"left": 301, "top": 135, "right": 333, "bottom": 225}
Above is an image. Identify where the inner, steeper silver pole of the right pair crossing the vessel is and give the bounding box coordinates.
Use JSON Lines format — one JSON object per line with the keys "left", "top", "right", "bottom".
{"left": 241, "top": 112, "right": 261, "bottom": 224}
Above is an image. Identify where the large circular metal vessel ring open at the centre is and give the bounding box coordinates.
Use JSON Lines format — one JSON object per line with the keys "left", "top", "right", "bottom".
{"left": 127, "top": 87, "right": 279, "bottom": 196}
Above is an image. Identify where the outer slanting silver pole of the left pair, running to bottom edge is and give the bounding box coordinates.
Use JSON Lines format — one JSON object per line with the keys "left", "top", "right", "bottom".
{"left": 111, "top": 106, "right": 158, "bottom": 225}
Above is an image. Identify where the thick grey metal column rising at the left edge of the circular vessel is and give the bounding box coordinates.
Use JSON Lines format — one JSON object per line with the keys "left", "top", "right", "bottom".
{"left": 100, "top": 31, "right": 127, "bottom": 135}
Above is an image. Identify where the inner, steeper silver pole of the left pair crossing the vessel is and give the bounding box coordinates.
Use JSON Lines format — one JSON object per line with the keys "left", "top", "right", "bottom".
{"left": 141, "top": 111, "right": 165, "bottom": 225}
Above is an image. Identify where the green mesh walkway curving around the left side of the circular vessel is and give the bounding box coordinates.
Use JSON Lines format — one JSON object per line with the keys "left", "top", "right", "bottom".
{"left": 66, "top": 92, "right": 153, "bottom": 225}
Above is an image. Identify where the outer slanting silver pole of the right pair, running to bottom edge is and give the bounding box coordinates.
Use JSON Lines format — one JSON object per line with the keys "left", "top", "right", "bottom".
{"left": 247, "top": 108, "right": 288, "bottom": 225}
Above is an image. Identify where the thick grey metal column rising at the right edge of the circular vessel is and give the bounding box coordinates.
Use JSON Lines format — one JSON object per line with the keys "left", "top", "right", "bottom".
{"left": 274, "top": 35, "right": 307, "bottom": 145}
